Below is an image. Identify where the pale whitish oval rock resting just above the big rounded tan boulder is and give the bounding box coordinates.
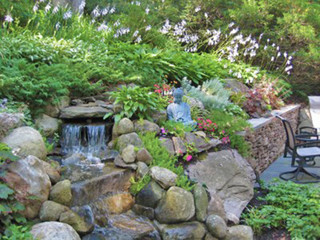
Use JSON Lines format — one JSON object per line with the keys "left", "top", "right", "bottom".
{"left": 150, "top": 166, "right": 178, "bottom": 189}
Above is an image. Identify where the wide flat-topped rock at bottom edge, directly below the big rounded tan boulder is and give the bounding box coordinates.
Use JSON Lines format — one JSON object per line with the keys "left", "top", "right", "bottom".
{"left": 161, "top": 222, "right": 207, "bottom": 240}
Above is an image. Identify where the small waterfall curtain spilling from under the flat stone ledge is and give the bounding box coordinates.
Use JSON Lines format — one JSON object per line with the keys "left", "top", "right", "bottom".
{"left": 61, "top": 124, "right": 108, "bottom": 157}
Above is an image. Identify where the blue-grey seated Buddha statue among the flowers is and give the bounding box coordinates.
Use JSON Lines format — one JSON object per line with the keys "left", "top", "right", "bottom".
{"left": 167, "top": 88, "right": 197, "bottom": 127}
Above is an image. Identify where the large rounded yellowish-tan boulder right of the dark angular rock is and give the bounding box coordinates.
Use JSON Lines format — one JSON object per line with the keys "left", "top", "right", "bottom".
{"left": 155, "top": 187, "right": 195, "bottom": 223}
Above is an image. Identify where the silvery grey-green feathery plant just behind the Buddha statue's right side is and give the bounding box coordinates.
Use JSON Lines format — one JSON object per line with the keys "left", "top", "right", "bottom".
{"left": 182, "top": 79, "right": 230, "bottom": 110}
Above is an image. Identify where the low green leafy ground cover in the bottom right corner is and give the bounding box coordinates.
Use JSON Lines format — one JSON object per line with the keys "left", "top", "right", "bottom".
{"left": 243, "top": 181, "right": 320, "bottom": 240}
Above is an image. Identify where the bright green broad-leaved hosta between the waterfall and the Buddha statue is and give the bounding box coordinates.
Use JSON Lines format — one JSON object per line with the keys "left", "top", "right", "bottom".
{"left": 104, "top": 86, "right": 163, "bottom": 122}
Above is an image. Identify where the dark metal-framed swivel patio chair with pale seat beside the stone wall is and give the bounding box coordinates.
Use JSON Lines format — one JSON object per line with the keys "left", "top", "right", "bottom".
{"left": 277, "top": 116, "right": 320, "bottom": 183}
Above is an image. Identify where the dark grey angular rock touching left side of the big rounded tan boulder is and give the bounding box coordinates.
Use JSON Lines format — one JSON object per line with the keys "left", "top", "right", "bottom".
{"left": 136, "top": 181, "right": 165, "bottom": 208}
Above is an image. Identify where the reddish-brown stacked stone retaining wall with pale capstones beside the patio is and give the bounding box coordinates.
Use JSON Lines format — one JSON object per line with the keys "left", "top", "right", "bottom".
{"left": 242, "top": 105, "right": 300, "bottom": 174}
